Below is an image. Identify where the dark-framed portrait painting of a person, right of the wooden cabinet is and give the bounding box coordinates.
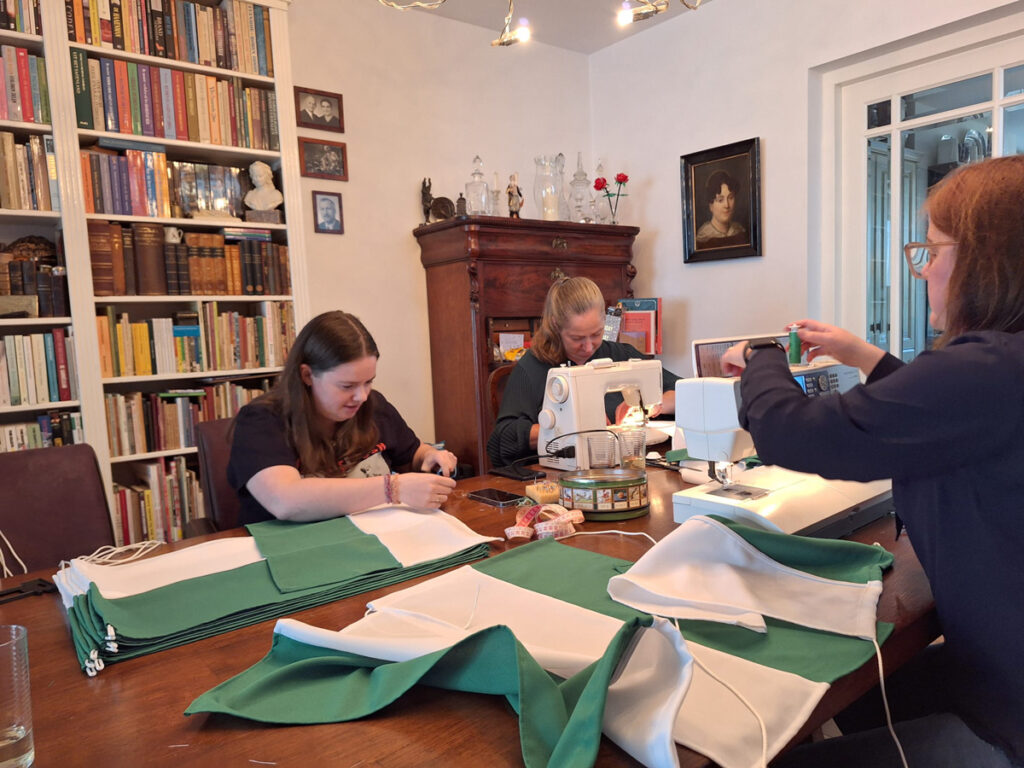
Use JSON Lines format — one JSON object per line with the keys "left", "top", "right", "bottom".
{"left": 679, "top": 138, "right": 761, "bottom": 263}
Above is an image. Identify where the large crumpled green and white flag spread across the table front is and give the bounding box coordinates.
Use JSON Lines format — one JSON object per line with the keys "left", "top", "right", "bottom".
{"left": 186, "top": 518, "right": 891, "bottom": 768}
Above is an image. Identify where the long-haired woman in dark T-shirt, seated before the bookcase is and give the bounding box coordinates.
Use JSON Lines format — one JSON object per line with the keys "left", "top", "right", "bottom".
{"left": 227, "top": 311, "right": 456, "bottom": 524}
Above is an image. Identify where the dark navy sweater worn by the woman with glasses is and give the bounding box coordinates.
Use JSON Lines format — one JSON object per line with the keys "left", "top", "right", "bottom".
{"left": 740, "top": 332, "right": 1024, "bottom": 763}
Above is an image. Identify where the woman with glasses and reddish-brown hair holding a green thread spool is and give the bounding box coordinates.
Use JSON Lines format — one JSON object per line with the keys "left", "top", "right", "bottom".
{"left": 723, "top": 156, "right": 1024, "bottom": 768}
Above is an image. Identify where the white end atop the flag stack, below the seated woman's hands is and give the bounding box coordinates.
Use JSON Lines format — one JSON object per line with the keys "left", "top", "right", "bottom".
{"left": 348, "top": 506, "right": 501, "bottom": 567}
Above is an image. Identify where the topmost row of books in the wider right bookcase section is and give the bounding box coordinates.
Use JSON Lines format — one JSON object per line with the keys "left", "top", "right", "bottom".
{"left": 65, "top": 0, "right": 273, "bottom": 77}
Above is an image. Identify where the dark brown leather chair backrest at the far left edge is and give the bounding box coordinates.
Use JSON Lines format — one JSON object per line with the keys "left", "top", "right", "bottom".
{"left": 0, "top": 442, "right": 114, "bottom": 573}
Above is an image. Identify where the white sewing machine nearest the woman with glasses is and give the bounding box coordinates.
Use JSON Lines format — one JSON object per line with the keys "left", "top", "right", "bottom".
{"left": 672, "top": 364, "right": 892, "bottom": 538}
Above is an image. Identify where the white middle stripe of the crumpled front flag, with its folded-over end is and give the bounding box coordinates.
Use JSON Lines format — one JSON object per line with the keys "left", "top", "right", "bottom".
{"left": 274, "top": 566, "right": 691, "bottom": 766}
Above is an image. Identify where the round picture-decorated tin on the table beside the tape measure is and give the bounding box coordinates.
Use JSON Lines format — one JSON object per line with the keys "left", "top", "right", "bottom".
{"left": 558, "top": 469, "right": 649, "bottom": 520}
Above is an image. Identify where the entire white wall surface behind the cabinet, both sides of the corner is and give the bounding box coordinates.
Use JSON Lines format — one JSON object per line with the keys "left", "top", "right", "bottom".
{"left": 286, "top": 0, "right": 1024, "bottom": 439}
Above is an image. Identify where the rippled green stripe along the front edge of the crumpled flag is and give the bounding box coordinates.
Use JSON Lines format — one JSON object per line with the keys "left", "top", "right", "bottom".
{"left": 185, "top": 620, "right": 641, "bottom": 768}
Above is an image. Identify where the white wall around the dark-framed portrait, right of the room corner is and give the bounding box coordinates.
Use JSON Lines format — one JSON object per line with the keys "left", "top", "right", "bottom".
{"left": 590, "top": 0, "right": 1022, "bottom": 374}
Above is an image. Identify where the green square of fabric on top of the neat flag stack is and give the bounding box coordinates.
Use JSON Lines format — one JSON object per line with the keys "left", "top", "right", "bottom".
{"left": 246, "top": 517, "right": 401, "bottom": 592}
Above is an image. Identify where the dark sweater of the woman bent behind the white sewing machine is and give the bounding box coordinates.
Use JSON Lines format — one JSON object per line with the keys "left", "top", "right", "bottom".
{"left": 487, "top": 341, "right": 679, "bottom": 467}
